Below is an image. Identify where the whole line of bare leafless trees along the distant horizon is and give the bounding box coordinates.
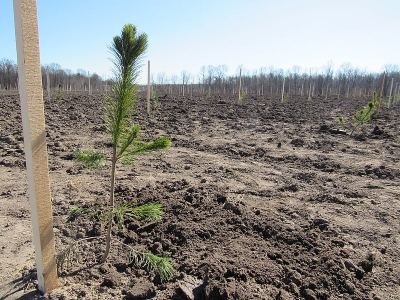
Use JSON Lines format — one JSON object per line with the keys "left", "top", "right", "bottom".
{"left": 0, "top": 58, "right": 400, "bottom": 100}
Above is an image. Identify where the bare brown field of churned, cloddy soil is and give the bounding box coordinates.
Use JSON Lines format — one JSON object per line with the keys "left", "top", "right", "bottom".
{"left": 0, "top": 93, "right": 400, "bottom": 300}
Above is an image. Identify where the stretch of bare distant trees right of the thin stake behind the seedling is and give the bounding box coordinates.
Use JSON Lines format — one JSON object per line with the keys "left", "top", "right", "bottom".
{"left": 151, "top": 63, "right": 400, "bottom": 96}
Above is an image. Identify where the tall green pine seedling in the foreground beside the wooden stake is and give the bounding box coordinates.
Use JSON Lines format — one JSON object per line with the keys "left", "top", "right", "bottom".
{"left": 71, "top": 24, "right": 172, "bottom": 276}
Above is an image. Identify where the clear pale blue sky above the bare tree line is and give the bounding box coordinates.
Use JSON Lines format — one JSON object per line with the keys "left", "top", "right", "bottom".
{"left": 0, "top": 0, "right": 400, "bottom": 81}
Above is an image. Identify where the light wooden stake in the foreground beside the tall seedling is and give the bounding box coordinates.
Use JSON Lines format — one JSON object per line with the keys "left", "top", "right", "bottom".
{"left": 14, "top": 0, "right": 58, "bottom": 294}
